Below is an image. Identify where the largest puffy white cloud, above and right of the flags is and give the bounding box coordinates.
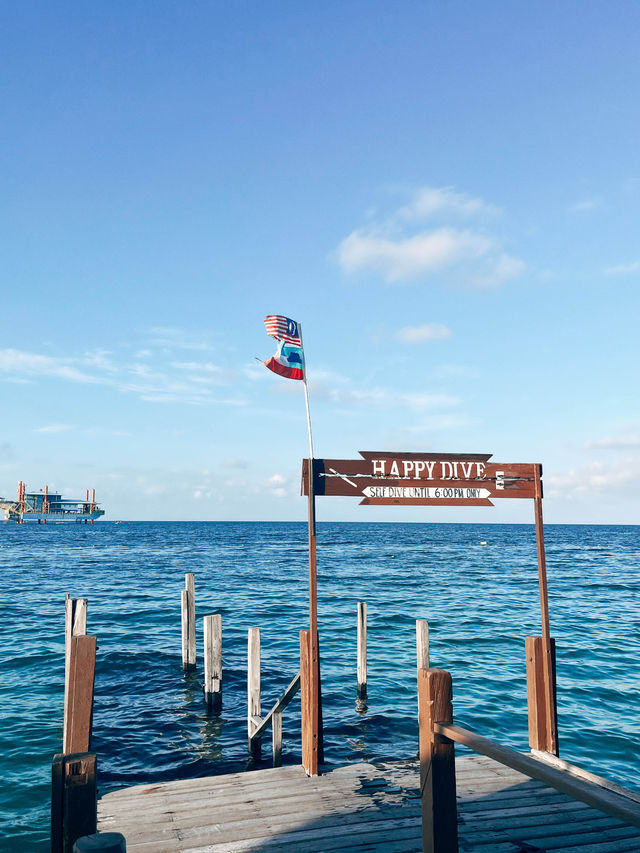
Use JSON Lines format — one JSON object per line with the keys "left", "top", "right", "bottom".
{"left": 335, "top": 187, "right": 525, "bottom": 287}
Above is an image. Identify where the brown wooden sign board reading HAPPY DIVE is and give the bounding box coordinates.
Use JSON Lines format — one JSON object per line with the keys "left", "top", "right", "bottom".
{"left": 302, "top": 450, "right": 542, "bottom": 506}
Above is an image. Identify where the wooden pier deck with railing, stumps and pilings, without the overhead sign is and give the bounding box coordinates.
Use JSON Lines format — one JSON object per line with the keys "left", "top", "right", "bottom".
{"left": 51, "top": 588, "right": 640, "bottom": 853}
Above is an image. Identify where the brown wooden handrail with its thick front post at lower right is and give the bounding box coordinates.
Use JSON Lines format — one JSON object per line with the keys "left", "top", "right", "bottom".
{"left": 418, "top": 667, "right": 640, "bottom": 853}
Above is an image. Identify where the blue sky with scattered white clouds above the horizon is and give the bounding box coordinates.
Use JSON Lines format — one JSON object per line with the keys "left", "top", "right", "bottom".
{"left": 0, "top": 0, "right": 640, "bottom": 523}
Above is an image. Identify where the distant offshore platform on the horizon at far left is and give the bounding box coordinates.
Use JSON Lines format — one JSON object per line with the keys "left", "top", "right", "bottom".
{"left": 0, "top": 480, "right": 104, "bottom": 524}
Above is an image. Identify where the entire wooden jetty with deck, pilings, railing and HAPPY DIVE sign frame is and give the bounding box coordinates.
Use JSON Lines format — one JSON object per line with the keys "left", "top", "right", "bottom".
{"left": 52, "top": 452, "right": 640, "bottom": 853}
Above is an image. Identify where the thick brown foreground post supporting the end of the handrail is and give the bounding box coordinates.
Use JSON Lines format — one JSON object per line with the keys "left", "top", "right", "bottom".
{"left": 418, "top": 668, "right": 458, "bottom": 853}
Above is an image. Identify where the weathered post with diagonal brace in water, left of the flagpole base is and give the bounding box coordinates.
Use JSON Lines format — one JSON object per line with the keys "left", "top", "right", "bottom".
{"left": 247, "top": 628, "right": 300, "bottom": 767}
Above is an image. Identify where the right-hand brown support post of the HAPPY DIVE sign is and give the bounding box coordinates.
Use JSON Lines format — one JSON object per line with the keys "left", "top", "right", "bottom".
{"left": 525, "top": 465, "right": 559, "bottom": 755}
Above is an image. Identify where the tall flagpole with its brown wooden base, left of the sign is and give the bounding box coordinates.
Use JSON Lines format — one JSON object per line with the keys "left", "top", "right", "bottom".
{"left": 298, "top": 323, "right": 323, "bottom": 776}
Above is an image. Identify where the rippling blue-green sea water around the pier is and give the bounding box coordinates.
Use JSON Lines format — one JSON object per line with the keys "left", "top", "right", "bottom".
{"left": 0, "top": 521, "right": 640, "bottom": 853}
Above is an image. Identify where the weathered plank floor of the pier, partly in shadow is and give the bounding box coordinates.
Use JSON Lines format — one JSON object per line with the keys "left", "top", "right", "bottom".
{"left": 98, "top": 756, "right": 640, "bottom": 853}
